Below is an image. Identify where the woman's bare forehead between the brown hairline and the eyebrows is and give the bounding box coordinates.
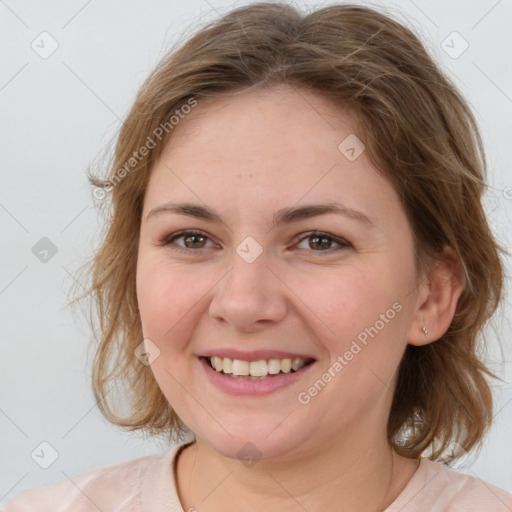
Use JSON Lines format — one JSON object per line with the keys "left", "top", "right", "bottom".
{"left": 143, "top": 87, "right": 399, "bottom": 228}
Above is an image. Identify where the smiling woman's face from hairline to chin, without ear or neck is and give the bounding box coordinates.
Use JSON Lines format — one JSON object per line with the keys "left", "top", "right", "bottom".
{"left": 137, "top": 87, "right": 424, "bottom": 458}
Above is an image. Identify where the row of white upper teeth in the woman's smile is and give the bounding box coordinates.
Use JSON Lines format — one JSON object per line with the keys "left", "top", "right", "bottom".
{"left": 208, "top": 356, "right": 306, "bottom": 377}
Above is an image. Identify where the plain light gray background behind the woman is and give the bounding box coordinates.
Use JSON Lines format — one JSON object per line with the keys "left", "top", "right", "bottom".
{"left": 0, "top": 0, "right": 512, "bottom": 505}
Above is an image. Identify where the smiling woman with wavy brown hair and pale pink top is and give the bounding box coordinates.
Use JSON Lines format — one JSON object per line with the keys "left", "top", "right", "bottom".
{"left": 6, "top": 3, "right": 512, "bottom": 512}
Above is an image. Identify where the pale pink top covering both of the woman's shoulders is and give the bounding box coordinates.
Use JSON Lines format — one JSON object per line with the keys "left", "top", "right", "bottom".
{"left": 3, "top": 440, "right": 512, "bottom": 512}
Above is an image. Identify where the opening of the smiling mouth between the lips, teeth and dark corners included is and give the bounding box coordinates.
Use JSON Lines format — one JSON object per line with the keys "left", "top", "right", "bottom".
{"left": 200, "top": 356, "right": 315, "bottom": 381}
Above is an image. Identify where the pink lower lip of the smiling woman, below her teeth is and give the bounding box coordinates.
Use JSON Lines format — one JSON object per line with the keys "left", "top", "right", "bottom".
{"left": 199, "top": 357, "right": 315, "bottom": 396}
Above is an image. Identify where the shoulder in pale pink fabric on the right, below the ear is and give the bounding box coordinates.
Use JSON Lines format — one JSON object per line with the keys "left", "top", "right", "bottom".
{"left": 386, "top": 459, "right": 512, "bottom": 512}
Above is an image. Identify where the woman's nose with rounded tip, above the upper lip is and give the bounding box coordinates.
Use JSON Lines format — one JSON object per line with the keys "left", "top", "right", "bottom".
{"left": 209, "top": 252, "right": 287, "bottom": 332}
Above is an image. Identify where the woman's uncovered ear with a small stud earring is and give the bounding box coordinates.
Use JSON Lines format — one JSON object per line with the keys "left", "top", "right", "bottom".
{"left": 407, "top": 247, "right": 465, "bottom": 346}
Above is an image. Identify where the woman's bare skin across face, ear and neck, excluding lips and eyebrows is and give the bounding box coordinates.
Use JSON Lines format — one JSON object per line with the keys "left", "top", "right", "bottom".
{"left": 137, "top": 86, "right": 462, "bottom": 512}
